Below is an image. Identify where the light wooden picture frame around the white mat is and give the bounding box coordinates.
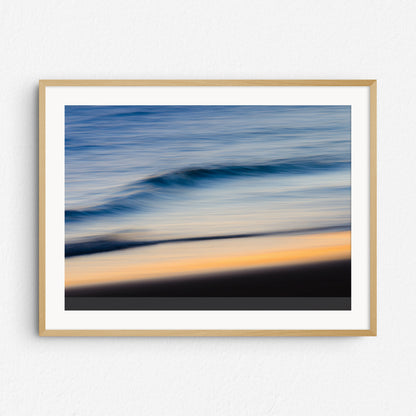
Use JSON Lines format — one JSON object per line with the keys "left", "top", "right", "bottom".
{"left": 38, "top": 79, "right": 377, "bottom": 337}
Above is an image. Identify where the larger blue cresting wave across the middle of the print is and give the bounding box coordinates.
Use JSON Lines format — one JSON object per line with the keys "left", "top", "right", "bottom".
{"left": 65, "top": 156, "right": 350, "bottom": 222}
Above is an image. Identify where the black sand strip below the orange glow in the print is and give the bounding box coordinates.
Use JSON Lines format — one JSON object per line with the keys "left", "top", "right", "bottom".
{"left": 66, "top": 260, "right": 351, "bottom": 310}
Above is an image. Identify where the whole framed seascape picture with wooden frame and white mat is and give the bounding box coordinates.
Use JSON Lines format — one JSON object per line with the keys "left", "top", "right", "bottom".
{"left": 39, "top": 80, "right": 376, "bottom": 336}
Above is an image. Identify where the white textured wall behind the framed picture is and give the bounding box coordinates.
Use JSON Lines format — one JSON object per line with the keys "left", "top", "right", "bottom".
{"left": 0, "top": 0, "right": 416, "bottom": 416}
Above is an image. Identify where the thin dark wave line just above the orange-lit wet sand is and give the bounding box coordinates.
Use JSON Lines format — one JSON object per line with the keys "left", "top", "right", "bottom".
{"left": 65, "top": 224, "right": 351, "bottom": 257}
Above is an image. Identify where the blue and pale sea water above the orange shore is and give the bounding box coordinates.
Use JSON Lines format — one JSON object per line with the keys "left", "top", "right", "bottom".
{"left": 65, "top": 106, "right": 351, "bottom": 254}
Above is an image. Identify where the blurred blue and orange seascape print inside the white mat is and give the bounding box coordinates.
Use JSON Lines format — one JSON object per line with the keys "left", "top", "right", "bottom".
{"left": 65, "top": 105, "right": 351, "bottom": 310}
